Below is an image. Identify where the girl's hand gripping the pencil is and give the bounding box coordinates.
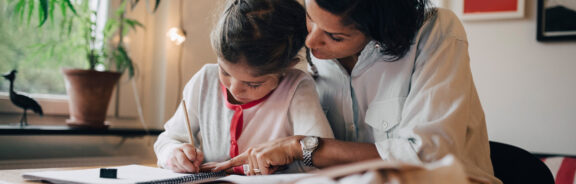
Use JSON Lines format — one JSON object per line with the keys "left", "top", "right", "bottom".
{"left": 166, "top": 144, "right": 204, "bottom": 173}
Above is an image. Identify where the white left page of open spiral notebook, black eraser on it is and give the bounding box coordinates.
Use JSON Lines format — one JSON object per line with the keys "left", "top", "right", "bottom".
{"left": 22, "top": 165, "right": 226, "bottom": 184}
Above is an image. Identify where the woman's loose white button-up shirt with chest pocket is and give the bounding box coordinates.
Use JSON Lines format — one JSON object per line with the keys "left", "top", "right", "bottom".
{"left": 313, "top": 9, "right": 500, "bottom": 183}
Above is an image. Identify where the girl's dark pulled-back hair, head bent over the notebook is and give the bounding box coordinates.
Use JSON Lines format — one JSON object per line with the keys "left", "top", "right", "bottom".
{"left": 211, "top": 0, "right": 307, "bottom": 75}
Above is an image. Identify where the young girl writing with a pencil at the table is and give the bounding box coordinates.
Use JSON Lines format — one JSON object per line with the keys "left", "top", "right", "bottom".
{"left": 154, "top": 0, "right": 333, "bottom": 174}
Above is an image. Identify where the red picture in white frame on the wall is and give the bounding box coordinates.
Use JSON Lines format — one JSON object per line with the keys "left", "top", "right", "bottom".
{"left": 455, "top": 0, "right": 525, "bottom": 20}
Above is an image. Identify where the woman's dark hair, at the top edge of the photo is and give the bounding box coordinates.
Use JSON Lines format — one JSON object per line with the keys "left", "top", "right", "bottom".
{"left": 315, "top": 0, "right": 436, "bottom": 61}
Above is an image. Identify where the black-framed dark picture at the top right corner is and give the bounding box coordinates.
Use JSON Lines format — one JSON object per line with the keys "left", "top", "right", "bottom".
{"left": 536, "top": 0, "right": 576, "bottom": 41}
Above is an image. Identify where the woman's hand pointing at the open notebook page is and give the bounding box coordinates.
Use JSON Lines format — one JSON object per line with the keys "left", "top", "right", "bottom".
{"left": 212, "top": 136, "right": 303, "bottom": 175}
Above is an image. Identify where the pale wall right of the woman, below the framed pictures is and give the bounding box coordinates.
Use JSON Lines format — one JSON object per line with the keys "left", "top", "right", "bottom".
{"left": 464, "top": 0, "right": 576, "bottom": 155}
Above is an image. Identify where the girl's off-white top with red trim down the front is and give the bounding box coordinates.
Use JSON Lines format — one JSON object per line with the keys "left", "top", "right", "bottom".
{"left": 154, "top": 64, "right": 334, "bottom": 171}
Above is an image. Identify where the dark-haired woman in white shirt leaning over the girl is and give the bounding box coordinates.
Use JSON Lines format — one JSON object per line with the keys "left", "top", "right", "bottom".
{"left": 210, "top": 0, "right": 501, "bottom": 183}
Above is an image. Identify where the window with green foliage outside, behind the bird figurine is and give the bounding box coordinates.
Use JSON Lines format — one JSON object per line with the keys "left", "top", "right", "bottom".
{"left": 0, "top": 0, "right": 108, "bottom": 114}
